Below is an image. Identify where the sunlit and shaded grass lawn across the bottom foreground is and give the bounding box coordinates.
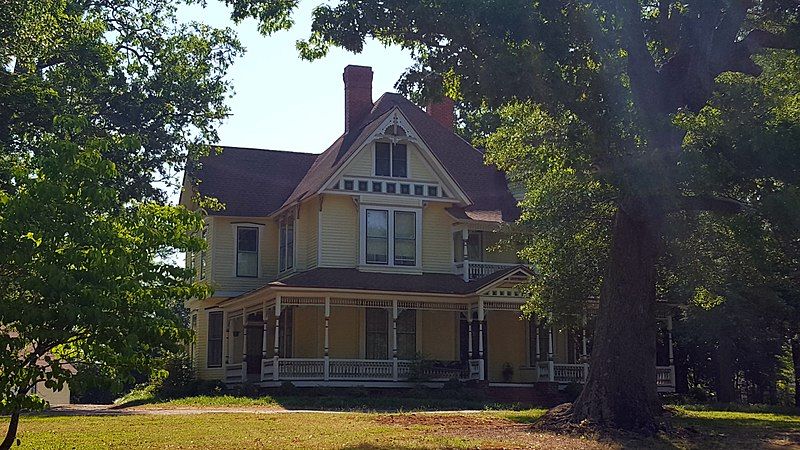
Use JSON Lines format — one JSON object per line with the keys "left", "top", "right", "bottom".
{"left": 0, "top": 399, "right": 800, "bottom": 449}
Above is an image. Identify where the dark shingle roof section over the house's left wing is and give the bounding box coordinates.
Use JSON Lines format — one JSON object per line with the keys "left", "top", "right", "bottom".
{"left": 188, "top": 147, "right": 319, "bottom": 217}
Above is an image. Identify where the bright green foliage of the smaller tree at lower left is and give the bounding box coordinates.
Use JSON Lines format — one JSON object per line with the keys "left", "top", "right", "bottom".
{"left": 0, "top": 121, "right": 209, "bottom": 412}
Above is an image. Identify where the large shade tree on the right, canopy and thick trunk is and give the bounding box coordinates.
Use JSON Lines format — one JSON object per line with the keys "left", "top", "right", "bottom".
{"left": 228, "top": 0, "right": 800, "bottom": 432}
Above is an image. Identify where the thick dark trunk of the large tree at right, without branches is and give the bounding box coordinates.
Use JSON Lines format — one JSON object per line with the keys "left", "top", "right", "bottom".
{"left": 571, "top": 207, "right": 661, "bottom": 433}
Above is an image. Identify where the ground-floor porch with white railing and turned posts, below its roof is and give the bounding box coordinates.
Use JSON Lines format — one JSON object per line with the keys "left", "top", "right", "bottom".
{"left": 217, "top": 278, "right": 675, "bottom": 392}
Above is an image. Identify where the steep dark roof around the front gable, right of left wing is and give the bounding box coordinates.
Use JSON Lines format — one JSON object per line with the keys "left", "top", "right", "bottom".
{"left": 283, "top": 93, "right": 519, "bottom": 222}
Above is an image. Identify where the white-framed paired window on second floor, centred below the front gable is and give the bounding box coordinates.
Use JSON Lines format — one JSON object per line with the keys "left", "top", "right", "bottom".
{"left": 362, "top": 208, "right": 420, "bottom": 267}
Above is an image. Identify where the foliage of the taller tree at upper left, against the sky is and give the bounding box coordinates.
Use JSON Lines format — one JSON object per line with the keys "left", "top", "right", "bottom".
{"left": 0, "top": 0, "right": 242, "bottom": 200}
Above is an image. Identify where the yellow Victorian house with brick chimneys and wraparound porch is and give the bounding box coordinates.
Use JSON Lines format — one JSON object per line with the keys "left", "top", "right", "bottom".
{"left": 181, "top": 66, "right": 674, "bottom": 396}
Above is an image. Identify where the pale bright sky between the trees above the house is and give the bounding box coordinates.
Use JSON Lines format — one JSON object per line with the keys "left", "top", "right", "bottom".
{"left": 179, "top": 0, "right": 412, "bottom": 153}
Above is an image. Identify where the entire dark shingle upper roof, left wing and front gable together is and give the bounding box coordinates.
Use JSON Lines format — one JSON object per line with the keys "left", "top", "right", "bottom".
{"left": 191, "top": 93, "right": 519, "bottom": 222}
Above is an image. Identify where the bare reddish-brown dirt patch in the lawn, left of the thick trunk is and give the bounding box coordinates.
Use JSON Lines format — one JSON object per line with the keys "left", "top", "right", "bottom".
{"left": 374, "top": 414, "right": 620, "bottom": 450}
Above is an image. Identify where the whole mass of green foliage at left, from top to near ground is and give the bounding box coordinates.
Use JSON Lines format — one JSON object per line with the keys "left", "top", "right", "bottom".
{"left": 0, "top": 0, "right": 247, "bottom": 445}
